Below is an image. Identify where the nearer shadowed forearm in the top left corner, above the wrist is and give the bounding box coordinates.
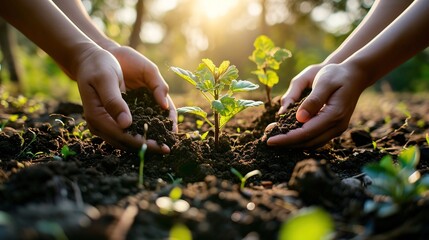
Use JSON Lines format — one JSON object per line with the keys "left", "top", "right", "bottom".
{"left": 0, "top": 0, "right": 97, "bottom": 78}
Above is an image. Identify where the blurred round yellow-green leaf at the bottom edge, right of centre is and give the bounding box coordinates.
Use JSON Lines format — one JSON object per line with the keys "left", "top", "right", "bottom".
{"left": 278, "top": 207, "right": 334, "bottom": 240}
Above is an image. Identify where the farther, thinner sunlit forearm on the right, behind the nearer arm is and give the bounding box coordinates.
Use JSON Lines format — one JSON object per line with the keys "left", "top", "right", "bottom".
{"left": 324, "top": 0, "right": 413, "bottom": 64}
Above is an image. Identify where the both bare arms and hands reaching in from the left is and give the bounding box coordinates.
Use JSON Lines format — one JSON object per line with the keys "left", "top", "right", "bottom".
{"left": 0, "top": 0, "right": 176, "bottom": 153}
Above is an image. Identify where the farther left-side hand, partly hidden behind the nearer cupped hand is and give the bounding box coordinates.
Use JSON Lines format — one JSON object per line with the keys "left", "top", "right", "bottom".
{"left": 107, "top": 46, "right": 177, "bottom": 132}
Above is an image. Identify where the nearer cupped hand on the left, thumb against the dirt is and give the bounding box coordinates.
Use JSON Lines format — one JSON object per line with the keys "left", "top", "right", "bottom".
{"left": 76, "top": 47, "right": 170, "bottom": 154}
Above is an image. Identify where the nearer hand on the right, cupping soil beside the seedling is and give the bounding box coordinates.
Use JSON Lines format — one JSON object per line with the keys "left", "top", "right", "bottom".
{"left": 267, "top": 64, "right": 367, "bottom": 148}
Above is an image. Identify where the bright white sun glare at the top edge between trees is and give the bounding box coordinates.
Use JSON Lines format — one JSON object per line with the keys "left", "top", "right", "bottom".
{"left": 196, "top": 0, "right": 237, "bottom": 19}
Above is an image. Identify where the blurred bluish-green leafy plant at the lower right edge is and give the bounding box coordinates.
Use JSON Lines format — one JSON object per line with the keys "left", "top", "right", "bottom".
{"left": 363, "top": 146, "right": 429, "bottom": 216}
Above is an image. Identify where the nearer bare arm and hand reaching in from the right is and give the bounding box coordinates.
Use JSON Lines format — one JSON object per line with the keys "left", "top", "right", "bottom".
{"left": 267, "top": 0, "right": 429, "bottom": 147}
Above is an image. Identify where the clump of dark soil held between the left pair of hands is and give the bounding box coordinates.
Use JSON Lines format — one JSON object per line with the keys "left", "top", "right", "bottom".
{"left": 122, "top": 88, "right": 176, "bottom": 147}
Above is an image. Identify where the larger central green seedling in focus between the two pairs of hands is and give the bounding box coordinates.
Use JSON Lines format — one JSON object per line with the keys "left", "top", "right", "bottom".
{"left": 170, "top": 58, "right": 263, "bottom": 147}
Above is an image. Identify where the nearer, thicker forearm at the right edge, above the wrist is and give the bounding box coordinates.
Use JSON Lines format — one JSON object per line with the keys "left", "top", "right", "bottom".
{"left": 344, "top": 0, "right": 429, "bottom": 86}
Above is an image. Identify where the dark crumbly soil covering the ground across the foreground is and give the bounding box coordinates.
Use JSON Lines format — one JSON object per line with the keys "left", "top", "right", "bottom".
{"left": 0, "top": 89, "right": 429, "bottom": 240}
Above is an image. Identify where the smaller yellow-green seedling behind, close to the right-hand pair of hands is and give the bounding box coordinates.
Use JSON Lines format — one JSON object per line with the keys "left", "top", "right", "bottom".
{"left": 249, "top": 35, "right": 292, "bottom": 106}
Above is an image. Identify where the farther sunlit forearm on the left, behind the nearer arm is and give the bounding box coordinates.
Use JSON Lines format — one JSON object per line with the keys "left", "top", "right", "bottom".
{"left": 53, "top": 0, "right": 118, "bottom": 49}
